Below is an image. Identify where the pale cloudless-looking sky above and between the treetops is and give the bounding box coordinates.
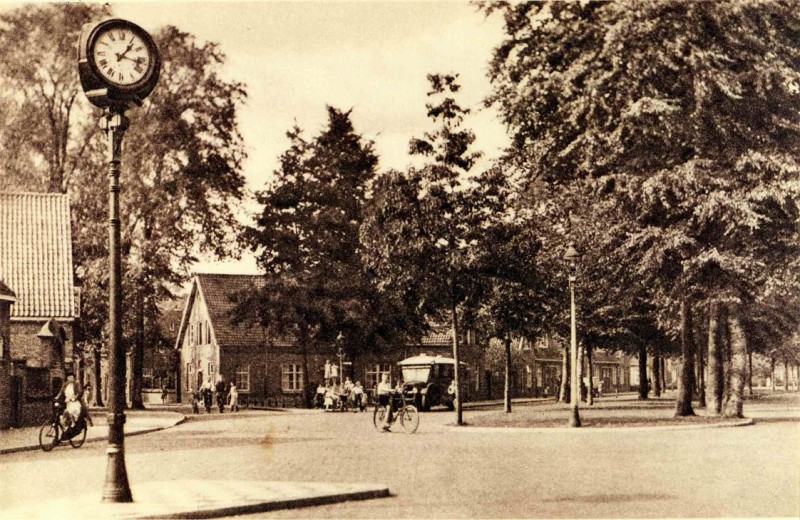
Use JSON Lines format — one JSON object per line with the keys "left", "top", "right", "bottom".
{"left": 20, "top": 1, "right": 506, "bottom": 272}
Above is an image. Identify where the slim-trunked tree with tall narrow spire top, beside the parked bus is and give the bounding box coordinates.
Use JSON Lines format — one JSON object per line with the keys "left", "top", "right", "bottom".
{"left": 362, "top": 74, "right": 487, "bottom": 426}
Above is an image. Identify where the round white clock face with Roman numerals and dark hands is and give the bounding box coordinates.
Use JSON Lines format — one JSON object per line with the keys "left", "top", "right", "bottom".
{"left": 91, "top": 26, "right": 151, "bottom": 86}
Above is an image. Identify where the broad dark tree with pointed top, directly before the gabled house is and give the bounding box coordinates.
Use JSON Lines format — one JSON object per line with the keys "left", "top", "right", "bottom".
{"left": 239, "top": 107, "right": 415, "bottom": 405}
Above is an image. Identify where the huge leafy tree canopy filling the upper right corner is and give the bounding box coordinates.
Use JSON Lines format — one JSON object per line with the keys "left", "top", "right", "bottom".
{"left": 484, "top": 1, "right": 800, "bottom": 415}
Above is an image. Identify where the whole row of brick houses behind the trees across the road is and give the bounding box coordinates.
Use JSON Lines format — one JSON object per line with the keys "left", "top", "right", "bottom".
{"left": 172, "top": 274, "right": 631, "bottom": 406}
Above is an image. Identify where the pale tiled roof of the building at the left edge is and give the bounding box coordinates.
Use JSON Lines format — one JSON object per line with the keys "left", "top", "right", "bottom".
{"left": 0, "top": 193, "right": 76, "bottom": 319}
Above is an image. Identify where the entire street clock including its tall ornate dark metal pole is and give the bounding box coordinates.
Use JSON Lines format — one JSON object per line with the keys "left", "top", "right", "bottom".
{"left": 78, "top": 19, "right": 161, "bottom": 502}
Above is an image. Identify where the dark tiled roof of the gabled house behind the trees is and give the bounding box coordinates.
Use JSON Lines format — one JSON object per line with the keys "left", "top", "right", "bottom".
{"left": 197, "top": 274, "right": 291, "bottom": 347}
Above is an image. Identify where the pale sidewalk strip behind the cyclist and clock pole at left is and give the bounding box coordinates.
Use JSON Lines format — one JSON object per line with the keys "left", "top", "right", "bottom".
{"left": 0, "top": 408, "right": 186, "bottom": 455}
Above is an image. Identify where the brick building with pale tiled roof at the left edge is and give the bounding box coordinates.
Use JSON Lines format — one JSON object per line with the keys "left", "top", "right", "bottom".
{"left": 0, "top": 193, "right": 79, "bottom": 426}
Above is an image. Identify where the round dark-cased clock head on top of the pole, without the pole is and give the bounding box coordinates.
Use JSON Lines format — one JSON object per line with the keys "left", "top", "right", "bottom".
{"left": 78, "top": 18, "right": 161, "bottom": 107}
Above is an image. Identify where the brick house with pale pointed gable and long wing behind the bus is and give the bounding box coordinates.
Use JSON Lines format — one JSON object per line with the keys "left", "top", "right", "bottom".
{"left": 175, "top": 274, "right": 480, "bottom": 406}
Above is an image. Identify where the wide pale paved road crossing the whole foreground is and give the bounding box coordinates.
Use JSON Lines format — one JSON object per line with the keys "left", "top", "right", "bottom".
{"left": 0, "top": 396, "right": 800, "bottom": 518}
